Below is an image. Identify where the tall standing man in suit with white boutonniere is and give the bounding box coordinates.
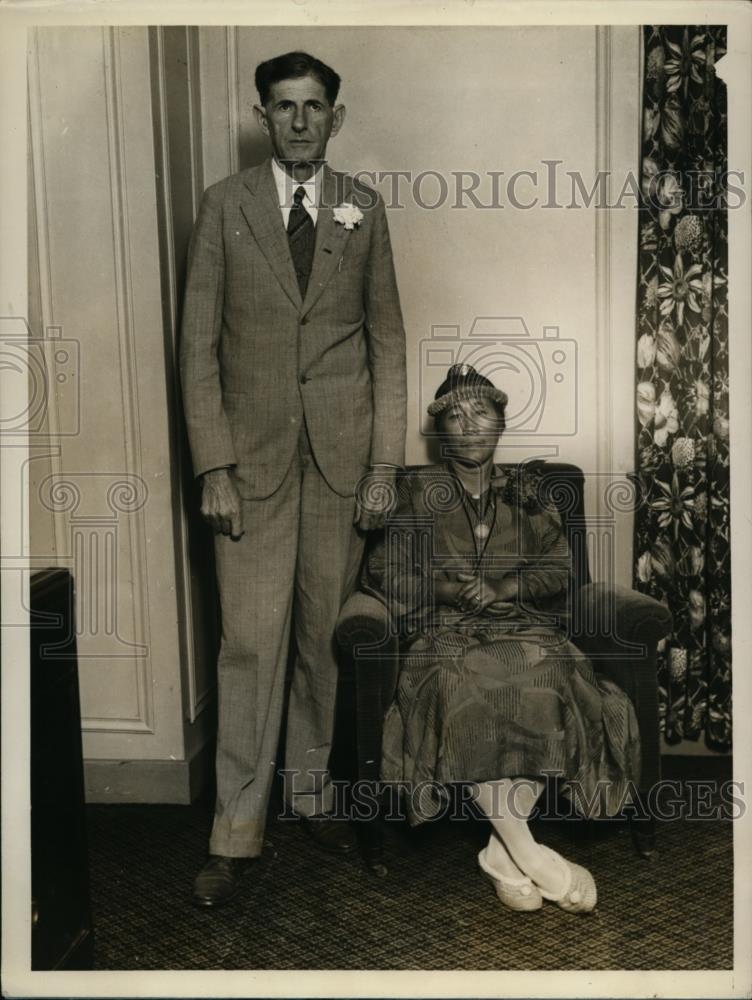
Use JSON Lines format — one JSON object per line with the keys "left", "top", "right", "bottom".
{"left": 180, "top": 52, "right": 406, "bottom": 906}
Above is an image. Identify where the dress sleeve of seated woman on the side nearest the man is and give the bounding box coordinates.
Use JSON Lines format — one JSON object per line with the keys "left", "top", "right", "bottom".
{"left": 361, "top": 476, "right": 430, "bottom": 632}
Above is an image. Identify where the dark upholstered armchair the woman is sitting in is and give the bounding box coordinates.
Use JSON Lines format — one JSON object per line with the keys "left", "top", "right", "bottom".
{"left": 337, "top": 460, "right": 672, "bottom": 874}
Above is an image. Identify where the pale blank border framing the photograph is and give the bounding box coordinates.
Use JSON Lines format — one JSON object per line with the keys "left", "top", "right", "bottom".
{"left": 0, "top": 0, "right": 752, "bottom": 997}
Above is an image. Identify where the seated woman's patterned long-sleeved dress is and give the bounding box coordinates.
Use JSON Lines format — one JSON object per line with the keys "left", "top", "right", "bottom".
{"left": 364, "top": 466, "right": 640, "bottom": 823}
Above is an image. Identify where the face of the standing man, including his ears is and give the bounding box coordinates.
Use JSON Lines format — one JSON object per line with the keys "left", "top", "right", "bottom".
{"left": 254, "top": 76, "right": 345, "bottom": 172}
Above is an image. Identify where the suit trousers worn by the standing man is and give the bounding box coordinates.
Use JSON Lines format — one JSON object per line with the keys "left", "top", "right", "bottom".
{"left": 209, "top": 428, "right": 363, "bottom": 857}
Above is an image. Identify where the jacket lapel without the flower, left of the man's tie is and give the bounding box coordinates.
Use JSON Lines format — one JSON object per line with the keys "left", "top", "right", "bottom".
{"left": 240, "top": 160, "right": 302, "bottom": 309}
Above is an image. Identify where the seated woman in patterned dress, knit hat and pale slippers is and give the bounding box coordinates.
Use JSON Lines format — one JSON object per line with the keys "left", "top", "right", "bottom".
{"left": 364, "top": 365, "right": 640, "bottom": 913}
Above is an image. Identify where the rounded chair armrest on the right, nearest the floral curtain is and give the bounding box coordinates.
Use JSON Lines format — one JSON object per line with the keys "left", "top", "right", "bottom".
{"left": 573, "top": 583, "right": 673, "bottom": 659}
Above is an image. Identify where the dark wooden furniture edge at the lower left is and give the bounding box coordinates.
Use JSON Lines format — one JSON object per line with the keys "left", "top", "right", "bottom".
{"left": 30, "top": 569, "right": 94, "bottom": 970}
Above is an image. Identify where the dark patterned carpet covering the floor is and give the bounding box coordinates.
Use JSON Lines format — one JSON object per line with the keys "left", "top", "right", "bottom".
{"left": 88, "top": 788, "right": 733, "bottom": 970}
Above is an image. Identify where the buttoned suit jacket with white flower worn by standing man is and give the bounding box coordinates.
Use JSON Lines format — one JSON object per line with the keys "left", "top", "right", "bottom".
{"left": 180, "top": 161, "right": 407, "bottom": 499}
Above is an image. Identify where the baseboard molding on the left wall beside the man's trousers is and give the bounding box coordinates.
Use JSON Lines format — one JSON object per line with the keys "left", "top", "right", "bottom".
{"left": 84, "top": 741, "right": 214, "bottom": 805}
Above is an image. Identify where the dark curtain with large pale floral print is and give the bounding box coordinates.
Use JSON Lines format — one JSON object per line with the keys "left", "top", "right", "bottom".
{"left": 634, "top": 26, "right": 731, "bottom": 750}
